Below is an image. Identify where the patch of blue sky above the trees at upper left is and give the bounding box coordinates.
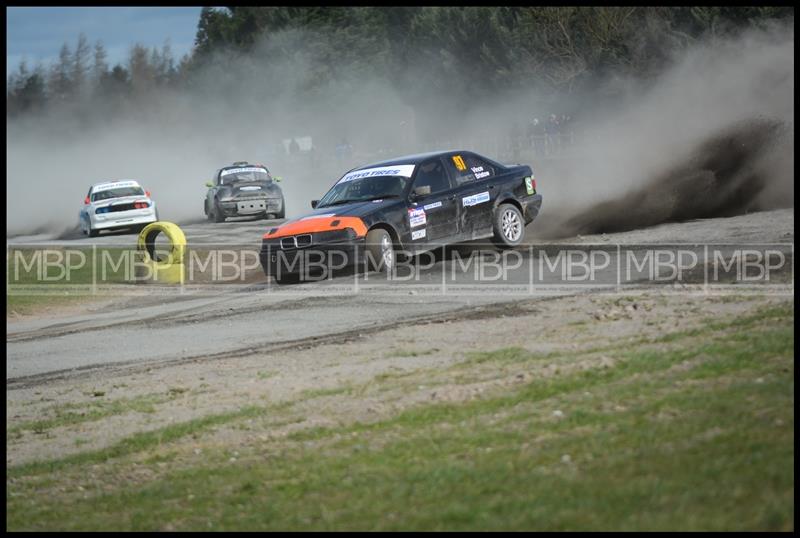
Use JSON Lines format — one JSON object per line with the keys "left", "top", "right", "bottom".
{"left": 6, "top": 7, "right": 201, "bottom": 76}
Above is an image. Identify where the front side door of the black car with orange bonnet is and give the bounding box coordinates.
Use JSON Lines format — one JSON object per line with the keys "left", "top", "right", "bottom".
{"left": 408, "top": 157, "right": 459, "bottom": 247}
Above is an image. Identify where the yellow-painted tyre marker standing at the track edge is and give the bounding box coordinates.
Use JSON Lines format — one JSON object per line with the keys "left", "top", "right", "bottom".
{"left": 136, "top": 221, "right": 186, "bottom": 284}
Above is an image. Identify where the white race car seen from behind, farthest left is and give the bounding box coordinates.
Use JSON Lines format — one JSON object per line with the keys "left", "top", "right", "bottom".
{"left": 79, "top": 180, "right": 158, "bottom": 237}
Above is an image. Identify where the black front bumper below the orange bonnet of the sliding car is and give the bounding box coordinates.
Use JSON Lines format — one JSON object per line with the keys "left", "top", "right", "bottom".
{"left": 260, "top": 239, "right": 367, "bottom": 278}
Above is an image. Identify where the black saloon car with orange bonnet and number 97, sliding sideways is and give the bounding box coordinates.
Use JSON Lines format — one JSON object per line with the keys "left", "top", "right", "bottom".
{"left": 261, "top": 151, "right": 542, "bottom": 280}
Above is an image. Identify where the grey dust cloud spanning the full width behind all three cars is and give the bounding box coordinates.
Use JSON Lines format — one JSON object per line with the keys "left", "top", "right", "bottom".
{"left": 6, "top": 25, "right": 794, "bottom": 236}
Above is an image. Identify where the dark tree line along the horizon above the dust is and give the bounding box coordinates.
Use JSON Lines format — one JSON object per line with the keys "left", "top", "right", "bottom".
{"left": 6, "top": 6, "right": 794, "bottom": 117}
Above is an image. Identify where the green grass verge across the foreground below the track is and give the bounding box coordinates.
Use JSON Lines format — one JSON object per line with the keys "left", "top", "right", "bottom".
{"left": 7, "top": 305, "right": 794, "bottom": 530}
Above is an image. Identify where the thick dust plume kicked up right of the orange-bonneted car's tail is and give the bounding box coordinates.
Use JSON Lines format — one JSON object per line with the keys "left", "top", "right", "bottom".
{"left": 524, "top": 23, "right": 794, "bottom": 237}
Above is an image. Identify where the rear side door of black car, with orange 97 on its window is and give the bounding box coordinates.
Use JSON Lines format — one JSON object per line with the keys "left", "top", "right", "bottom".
{"left": 445, "top": 153, "right": 499, "bottom": 239}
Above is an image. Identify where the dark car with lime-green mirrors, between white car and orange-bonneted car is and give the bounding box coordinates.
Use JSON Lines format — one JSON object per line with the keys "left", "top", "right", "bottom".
{"left": 203, "top": 161, "right": 286, "bottom": 222}
